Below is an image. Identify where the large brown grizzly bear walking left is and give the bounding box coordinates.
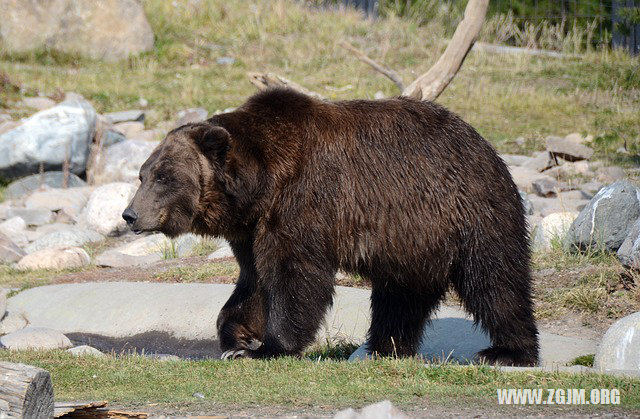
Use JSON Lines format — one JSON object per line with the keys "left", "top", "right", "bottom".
{"left": 123, "top": 89, "right": 538, "bottom": 365}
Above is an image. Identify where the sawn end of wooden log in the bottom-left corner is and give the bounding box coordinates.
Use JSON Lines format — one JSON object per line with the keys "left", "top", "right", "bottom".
{"left": 0, "top": 362, "right": 53, "bottom": 418}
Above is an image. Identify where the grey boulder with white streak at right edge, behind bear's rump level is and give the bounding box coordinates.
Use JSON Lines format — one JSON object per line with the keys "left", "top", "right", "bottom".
{"left": 567, "top": 180, "right": 640, "bottom": 252}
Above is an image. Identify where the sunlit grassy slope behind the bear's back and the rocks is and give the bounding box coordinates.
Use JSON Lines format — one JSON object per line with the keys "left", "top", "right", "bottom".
{"left": 0, "top": 0, "right": 640, "bottom": 159}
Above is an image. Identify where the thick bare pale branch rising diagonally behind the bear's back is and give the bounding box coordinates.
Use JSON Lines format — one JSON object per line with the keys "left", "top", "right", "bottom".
{"left": 402, "top": 0, "right": 489, "bottom": 100}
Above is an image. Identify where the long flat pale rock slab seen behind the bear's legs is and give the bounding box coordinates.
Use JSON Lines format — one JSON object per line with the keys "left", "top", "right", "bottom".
{"left": 7, "top": 282, "right": 597, "bottom": 364}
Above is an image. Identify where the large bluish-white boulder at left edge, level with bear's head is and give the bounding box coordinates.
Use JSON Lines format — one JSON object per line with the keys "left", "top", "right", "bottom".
{"left": 0, "top": 97, "right": 96, "bottom": 179}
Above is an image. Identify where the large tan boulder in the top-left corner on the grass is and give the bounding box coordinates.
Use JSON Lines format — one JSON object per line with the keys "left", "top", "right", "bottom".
{"left": 0, "top": 0, "right": 154, "bottom": 61}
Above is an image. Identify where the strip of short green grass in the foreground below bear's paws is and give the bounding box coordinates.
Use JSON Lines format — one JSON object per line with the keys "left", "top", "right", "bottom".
{"left": 0, "top": 351, "right": 640, "bottom": 412}
